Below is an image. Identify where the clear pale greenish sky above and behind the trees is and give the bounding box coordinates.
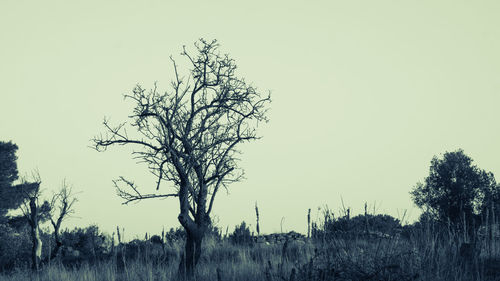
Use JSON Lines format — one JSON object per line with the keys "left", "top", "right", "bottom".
{"left": 0, "top": 0, "right": 500, "bottom": 238}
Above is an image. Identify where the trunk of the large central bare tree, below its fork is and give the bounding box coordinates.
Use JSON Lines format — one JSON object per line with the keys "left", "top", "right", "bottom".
{"left": 179, "top": 229, "right": 204, "bottom": 280}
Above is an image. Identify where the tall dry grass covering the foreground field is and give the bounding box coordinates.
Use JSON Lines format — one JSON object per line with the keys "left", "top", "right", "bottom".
{"left": 0, "top": 225, "right": 500, "bottom": 281}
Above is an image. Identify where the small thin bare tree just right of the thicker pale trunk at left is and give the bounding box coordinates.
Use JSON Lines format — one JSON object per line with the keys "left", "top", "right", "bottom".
{"left": 49, "top": 180, "right": 77, "bottom": 259}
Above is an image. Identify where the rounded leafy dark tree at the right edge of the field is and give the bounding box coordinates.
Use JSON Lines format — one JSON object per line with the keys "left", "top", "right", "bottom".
{"left": 410, "top": 149, "right": 498, "bottom": 231}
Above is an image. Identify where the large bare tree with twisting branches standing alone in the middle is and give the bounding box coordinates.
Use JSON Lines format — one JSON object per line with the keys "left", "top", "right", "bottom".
{"left": 93, "top": 39, "right": 271, "bottom": 276}
